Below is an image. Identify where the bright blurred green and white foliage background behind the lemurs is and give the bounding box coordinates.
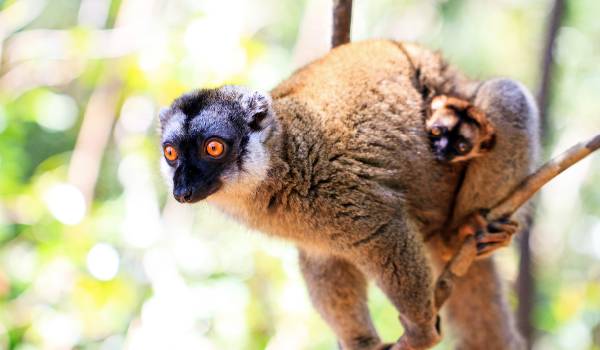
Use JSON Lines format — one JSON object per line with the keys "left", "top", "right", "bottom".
{"left": 0, "top": 0, "right": 600, "bottom": 350}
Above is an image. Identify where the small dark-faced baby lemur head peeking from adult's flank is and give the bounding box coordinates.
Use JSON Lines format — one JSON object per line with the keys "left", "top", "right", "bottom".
{"left": 426, "top": 95, "right": 496, "bottom": 163}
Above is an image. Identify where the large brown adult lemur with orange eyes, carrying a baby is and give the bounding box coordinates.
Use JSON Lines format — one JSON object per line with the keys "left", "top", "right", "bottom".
{"left": 160, "top": 41, "right": 538, "bottom": 349}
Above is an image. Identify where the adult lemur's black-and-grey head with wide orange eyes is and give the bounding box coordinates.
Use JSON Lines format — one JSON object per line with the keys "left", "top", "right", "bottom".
{"left": 160, "top": 86, "right": 274, "bottom": 203}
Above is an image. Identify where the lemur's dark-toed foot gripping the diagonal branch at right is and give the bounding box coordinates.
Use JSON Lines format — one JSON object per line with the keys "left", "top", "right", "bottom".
{"left": 459, "top": 210, "right": 519, "bottom": 258}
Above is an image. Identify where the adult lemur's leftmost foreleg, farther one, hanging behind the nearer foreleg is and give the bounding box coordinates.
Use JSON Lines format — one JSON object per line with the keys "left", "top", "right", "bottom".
{"left": 300, "top": 250, "right": 381, "bottom": 350}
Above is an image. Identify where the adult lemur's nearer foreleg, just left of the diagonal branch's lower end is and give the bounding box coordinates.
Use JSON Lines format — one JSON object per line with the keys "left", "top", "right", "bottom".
{"left": 353, "top": 219, "right": 441, "bottom": 350}
